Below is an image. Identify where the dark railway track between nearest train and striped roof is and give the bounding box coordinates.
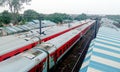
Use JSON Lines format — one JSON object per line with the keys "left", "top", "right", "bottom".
{"left": 50, "top": 30, "right": 94, "bottom": 72}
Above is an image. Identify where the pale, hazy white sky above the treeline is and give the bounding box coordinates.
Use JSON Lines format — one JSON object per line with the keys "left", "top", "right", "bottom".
{"left": 0, "top": 0, "right": 120, "bottom": 14}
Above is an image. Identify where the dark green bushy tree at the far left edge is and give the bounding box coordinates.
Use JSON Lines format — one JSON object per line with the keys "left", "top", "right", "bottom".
{"left": 0, "top": 11, "right": 11, "bottom": 24}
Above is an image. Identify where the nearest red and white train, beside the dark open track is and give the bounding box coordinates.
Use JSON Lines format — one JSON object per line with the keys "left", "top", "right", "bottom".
{"left": 0, "top": 20, "right": 96, "bottom": 72}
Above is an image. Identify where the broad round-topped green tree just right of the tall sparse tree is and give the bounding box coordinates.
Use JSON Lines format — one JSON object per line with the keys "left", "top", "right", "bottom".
{"left": 23, "top": 10, "right": 40, "bottom": 21}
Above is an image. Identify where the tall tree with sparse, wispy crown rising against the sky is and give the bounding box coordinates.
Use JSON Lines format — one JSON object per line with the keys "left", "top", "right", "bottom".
{"left": 0, "top": 0, "right": 31, "bottom": 23}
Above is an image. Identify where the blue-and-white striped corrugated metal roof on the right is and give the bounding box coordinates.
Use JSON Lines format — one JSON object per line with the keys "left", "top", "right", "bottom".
{"left": 79, "top": 27, "right": 120, "bottom": 72}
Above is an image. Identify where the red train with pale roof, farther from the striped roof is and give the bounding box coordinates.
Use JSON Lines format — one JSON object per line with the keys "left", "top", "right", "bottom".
{"left": 0, "top": 20, "right": 91, "bottom": 62}
